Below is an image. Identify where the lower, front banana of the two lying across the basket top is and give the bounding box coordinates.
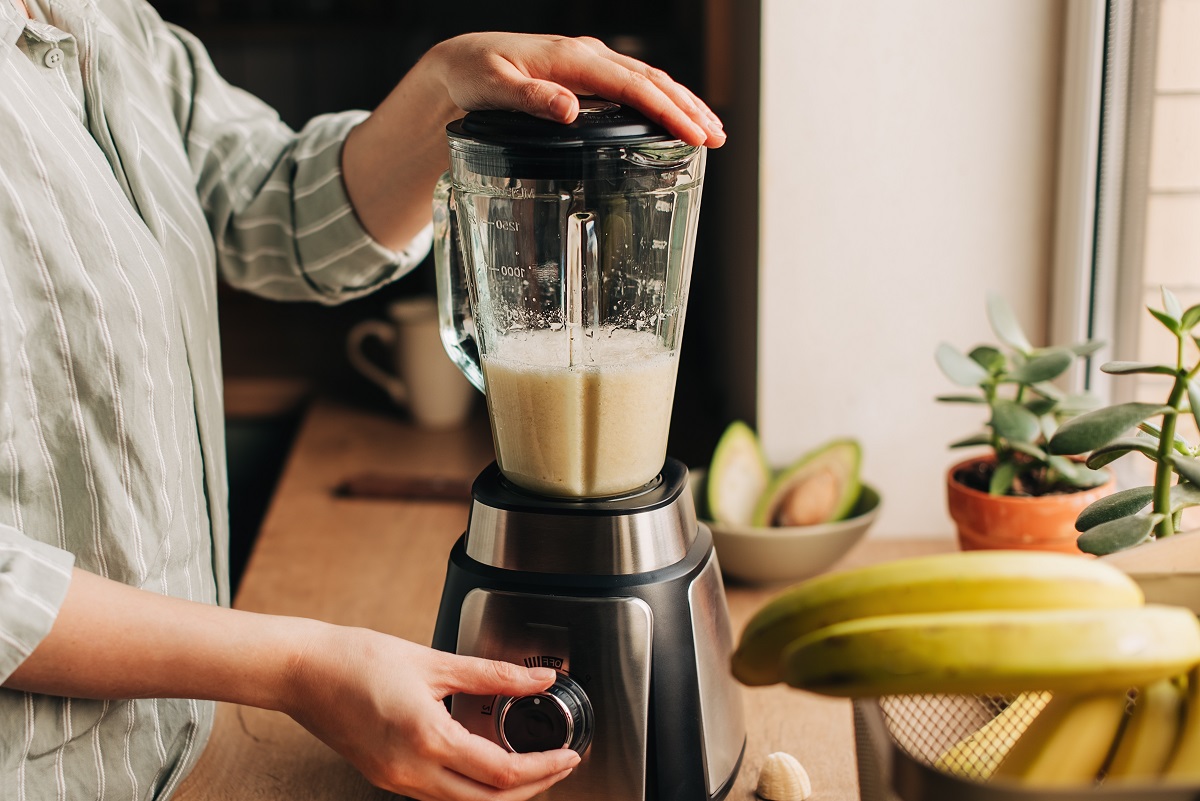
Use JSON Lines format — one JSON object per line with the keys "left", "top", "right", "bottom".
{"left": 781, "top": 606, "right": 1200, "bottom": 698}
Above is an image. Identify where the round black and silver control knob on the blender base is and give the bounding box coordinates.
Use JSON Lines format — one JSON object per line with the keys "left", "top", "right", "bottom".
{"left": 496, "top": 674, "right": 594, "bottom": 754}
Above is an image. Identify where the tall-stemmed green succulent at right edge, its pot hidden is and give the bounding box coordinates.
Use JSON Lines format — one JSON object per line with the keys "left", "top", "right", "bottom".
{"left": 1048, "top": 288, "right": 1200, "bottom": 554}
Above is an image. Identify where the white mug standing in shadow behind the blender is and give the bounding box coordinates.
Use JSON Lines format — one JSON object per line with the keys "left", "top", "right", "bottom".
{"left": 346, "top": 297, "right": 476, "bottom": 428}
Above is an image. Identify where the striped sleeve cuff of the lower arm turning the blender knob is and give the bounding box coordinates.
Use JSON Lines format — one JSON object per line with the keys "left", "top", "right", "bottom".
{"left": 0, "top": 525, "right": 74, "bottom": 683}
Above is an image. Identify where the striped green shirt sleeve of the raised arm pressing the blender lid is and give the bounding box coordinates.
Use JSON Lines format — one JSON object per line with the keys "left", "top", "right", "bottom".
{"left": 144, "top": 8, "right": 432, "bottom": 303}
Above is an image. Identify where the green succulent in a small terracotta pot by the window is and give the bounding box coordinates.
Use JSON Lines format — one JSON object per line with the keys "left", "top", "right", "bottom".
{"left": 936, "top": 295, "right": 1114, "bottom": 553}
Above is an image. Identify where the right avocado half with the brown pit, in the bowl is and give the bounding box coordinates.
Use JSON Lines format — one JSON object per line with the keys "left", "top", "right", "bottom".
{"left": 751, "top": 439, "right": 863, "bottom": 526}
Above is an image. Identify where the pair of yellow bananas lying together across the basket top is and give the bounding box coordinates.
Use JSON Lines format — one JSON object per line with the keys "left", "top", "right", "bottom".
{"left": 732, "top": 550, "right": 1185, "bottom": 695}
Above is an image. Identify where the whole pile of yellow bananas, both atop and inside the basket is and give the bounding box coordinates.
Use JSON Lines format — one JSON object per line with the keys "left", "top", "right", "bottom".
{"left": 732, "top": 550, "right": 1200, "bottom": 785}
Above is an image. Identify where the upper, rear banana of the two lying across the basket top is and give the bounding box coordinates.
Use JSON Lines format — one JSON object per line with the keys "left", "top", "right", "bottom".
{"left": 732, "top": 550, "right": 1144, "bottom": 686}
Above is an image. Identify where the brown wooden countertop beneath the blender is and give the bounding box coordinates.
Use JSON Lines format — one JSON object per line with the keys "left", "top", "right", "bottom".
{"left": 176, "top": 401, "right": 953, "bottom": 801}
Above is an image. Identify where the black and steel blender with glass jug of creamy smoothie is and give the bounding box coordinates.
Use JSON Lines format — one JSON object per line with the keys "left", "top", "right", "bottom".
{"left": 433, "top": 98, "right": 745, "bottom": 801}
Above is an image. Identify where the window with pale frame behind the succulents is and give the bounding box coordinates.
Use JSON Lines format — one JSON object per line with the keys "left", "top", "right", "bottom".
{"left": 1051, "top": 0, "right": 1200, "bottom": 484}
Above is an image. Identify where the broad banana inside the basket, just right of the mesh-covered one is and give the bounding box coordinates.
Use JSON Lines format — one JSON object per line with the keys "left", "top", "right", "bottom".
{"left": 992, "top": 691, "right": 1128, "bottom": 787}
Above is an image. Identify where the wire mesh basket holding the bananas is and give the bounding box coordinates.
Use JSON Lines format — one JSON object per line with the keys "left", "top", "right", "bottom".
{"left": 854, "top": 693, "right": 1200, "bottom": 801}
